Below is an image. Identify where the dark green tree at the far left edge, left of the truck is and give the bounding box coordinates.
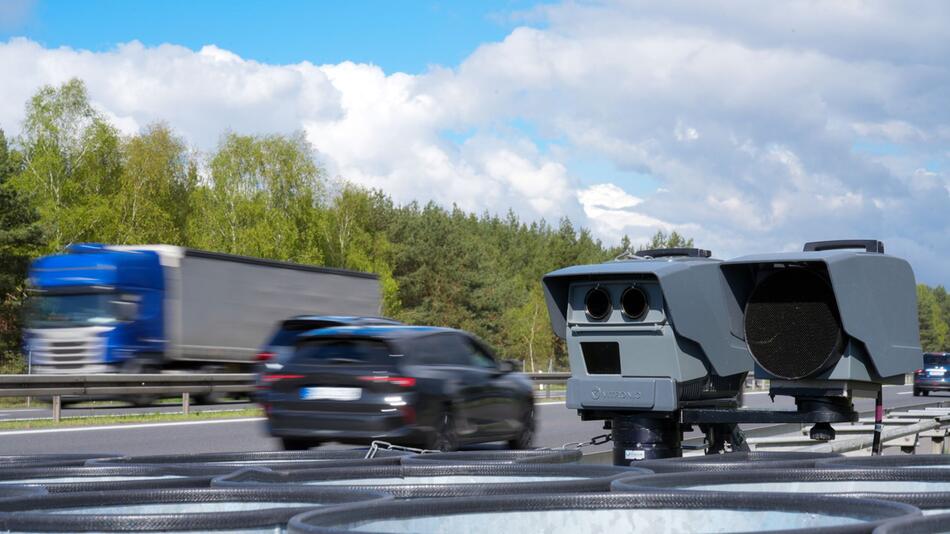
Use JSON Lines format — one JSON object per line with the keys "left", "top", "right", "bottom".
{"left": 0, "top": 130, "right": 43, "bottom": 371}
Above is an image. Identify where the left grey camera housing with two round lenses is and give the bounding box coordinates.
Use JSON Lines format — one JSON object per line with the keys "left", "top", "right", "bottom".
{"left": 542, "top": 249, "right": 752, "bottom": 419}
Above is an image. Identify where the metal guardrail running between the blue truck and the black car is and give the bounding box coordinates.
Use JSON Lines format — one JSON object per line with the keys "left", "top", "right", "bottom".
{"left": 0, "top": 373, "right": 571, "bottom": 421}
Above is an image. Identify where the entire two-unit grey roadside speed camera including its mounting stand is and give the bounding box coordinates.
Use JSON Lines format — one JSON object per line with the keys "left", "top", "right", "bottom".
{"left": 542, "top": 241, "right": 922, "bottom": 464}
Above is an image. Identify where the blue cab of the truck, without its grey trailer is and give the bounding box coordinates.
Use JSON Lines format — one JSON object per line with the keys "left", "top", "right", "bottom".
{"left": 25, "top": 244, "right": 165, "bottom": 373}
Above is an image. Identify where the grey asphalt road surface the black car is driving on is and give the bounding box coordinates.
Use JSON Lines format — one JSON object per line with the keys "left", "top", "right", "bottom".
{"left": 0, "top": 386, "right": 950, "bottom": 455}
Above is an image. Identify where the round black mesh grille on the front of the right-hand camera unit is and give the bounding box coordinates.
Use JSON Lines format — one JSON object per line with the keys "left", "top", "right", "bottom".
{"left": 745, "top": 268, "right": 844, "bottom": 380}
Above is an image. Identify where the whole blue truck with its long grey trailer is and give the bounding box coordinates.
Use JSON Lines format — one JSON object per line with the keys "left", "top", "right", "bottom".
{"left": 24, "top": 244, "right": 380, "bottom": 374}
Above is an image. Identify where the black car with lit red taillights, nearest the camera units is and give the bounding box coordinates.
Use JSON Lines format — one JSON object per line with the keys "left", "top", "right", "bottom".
{"left": 262, "top": 326, "right": 535, "bottom": 450}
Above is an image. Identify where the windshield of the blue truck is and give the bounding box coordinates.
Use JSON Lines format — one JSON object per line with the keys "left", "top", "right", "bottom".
{"left": 27, "top": 293, "right": 116, "bottom": 328}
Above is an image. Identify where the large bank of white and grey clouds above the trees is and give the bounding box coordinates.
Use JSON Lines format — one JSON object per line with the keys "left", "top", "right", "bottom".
{"left": 0, "top": 0, "right": 950, "bottom": 283}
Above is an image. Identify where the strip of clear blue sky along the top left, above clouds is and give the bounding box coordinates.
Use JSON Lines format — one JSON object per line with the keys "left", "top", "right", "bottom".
{"left": 0, "top": 0, "right": 538, "bottom": 73}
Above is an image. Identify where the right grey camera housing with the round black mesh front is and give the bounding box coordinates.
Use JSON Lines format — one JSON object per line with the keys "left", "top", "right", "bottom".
{"left": 721, "top": 240, "right": 923, "bottom": 394}
